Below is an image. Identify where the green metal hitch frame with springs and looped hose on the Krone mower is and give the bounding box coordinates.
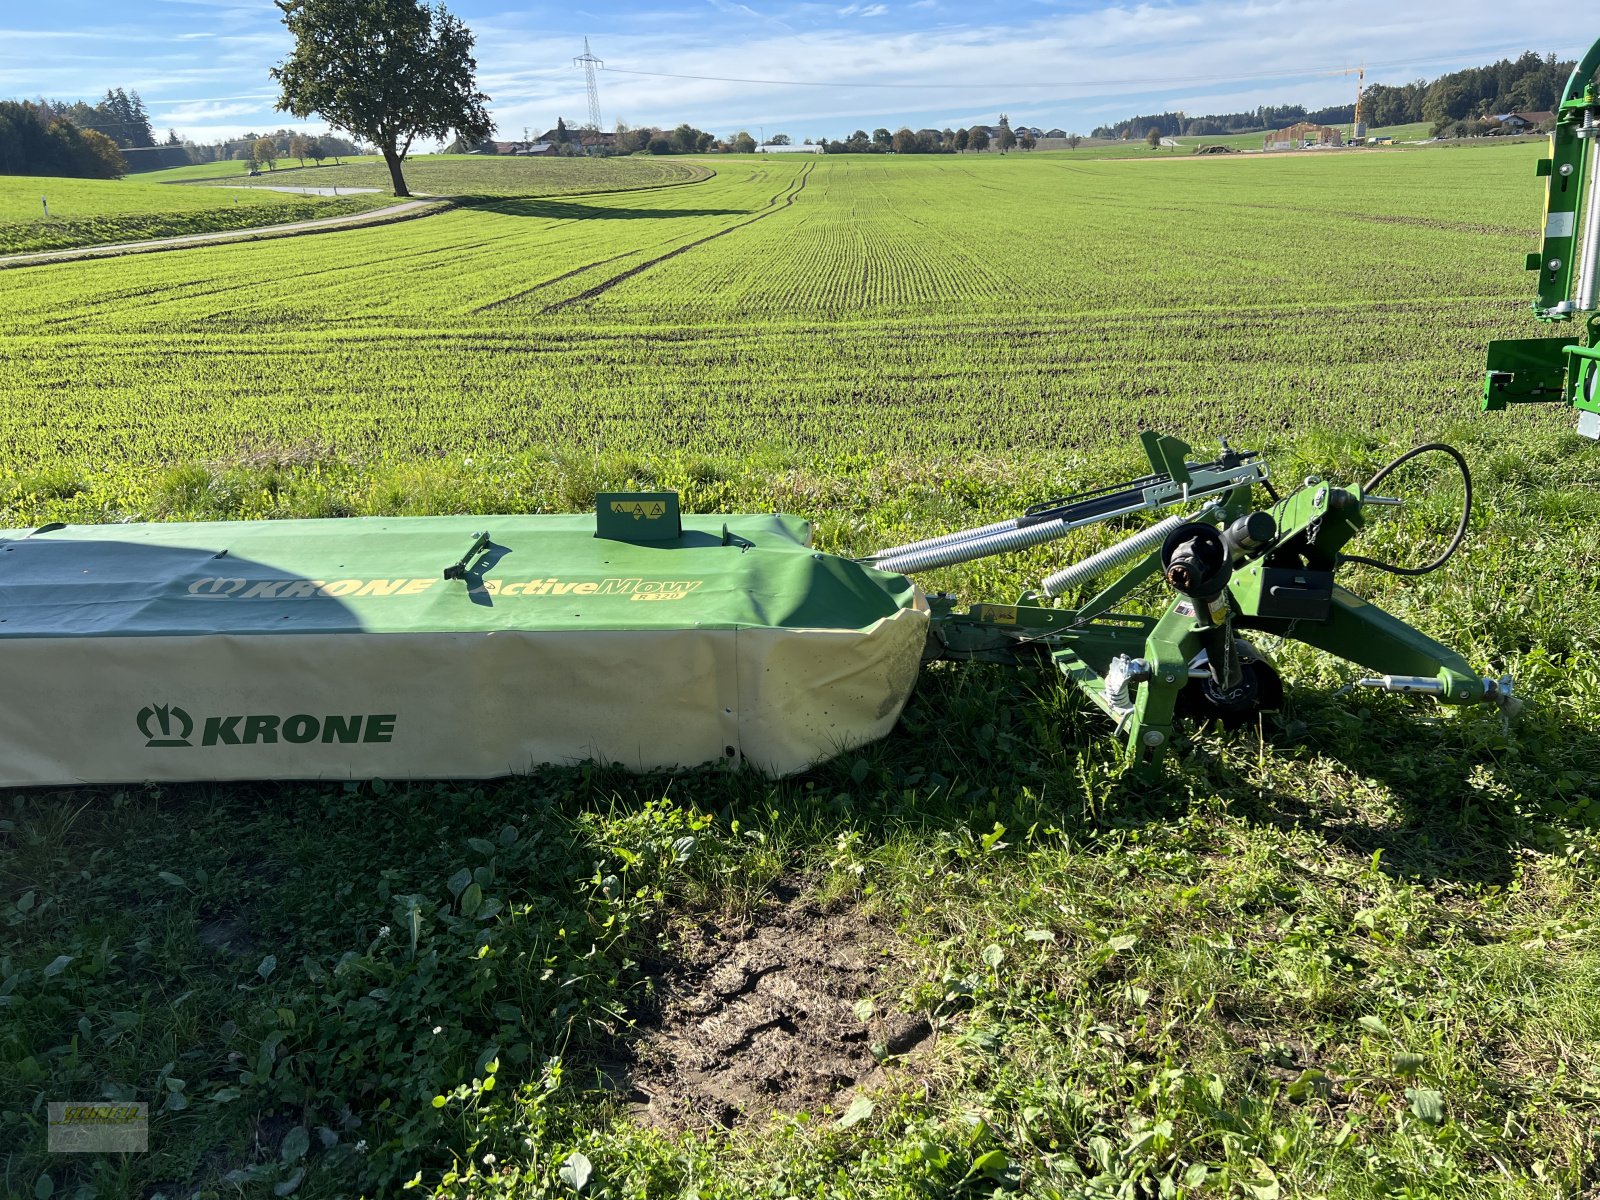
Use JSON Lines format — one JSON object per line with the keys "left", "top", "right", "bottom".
{"left": 896, "top": 434, "right": 1520, "bottom": 763}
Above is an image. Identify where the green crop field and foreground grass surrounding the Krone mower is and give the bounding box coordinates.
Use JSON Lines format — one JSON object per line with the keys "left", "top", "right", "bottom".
{"left": 0, "top": 146, "right": 1600, "bottom": 1200}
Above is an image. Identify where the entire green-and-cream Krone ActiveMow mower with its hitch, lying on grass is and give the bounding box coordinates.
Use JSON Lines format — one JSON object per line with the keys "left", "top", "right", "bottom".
{"left": 0, "top": 432, "right": 1515, "bottom": 786}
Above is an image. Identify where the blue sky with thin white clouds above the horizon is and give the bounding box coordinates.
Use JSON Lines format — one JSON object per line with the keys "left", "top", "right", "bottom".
{"left": 0, "top": 0, "right": 1582, "bottom": 149}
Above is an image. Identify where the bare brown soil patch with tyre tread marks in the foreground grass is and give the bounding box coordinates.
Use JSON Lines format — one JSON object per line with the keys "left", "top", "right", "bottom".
{"left": 613, "top": 886, "right": 933, "bottom": 1130}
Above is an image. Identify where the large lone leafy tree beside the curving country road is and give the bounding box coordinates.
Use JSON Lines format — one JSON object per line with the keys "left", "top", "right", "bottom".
{"left": 272, "top": 0, "right": 494, "bottom": 195}
